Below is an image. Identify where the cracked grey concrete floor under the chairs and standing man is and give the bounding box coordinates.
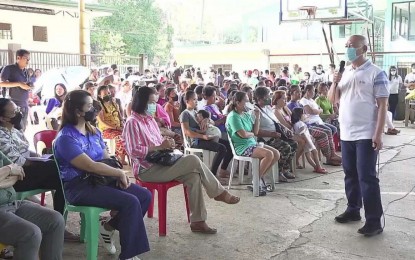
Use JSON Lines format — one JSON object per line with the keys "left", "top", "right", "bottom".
{"left": 26, "top": 124, "right": 415, "bottom": 260}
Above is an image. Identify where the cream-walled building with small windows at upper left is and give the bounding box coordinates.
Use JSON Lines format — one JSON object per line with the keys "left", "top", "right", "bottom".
{"left": 0, "top": 0, "right": 111, "bottom": 53}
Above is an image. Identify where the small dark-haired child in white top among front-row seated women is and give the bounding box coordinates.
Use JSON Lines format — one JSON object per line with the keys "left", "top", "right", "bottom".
{"left": 291, "top": 107, "right": 327, "bottom": 174}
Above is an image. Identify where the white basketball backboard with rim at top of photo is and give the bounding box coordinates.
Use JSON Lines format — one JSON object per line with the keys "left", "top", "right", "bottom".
{"left": 280, "top": 0, "right": 347, "bottom": 23}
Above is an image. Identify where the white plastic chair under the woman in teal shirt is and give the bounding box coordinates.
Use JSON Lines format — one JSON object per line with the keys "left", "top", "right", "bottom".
{"left": 228, "top": 133, "right": 279, "bottom": 197}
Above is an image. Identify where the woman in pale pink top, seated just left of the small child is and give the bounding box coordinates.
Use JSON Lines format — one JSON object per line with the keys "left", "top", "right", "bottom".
{"left": 271, "top": 90, "right": 307, "bottom": 169}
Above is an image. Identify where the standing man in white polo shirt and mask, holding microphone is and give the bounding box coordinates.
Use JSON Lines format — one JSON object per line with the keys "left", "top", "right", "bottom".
{"left": 329, "top": 35, "right": 389, "bottom": 236}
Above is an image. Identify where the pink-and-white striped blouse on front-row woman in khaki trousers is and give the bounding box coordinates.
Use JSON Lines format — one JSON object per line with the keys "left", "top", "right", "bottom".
{"left": 122, "top": 112, "right": 163, "bottom": 176}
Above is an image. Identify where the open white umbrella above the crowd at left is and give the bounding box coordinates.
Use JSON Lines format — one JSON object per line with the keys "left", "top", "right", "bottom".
{"left": 33, "top": 66, "right": 90, "bottom": 99}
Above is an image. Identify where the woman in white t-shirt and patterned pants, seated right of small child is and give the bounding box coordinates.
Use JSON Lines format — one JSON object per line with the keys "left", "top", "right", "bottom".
{"left": 300, "top": 84, "right": 341, "bottom": 166}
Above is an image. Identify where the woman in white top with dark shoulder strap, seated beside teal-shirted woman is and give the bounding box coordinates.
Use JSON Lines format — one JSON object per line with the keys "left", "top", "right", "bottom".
{"left": 254, "top": 87, "right": 298, "bottom": 182}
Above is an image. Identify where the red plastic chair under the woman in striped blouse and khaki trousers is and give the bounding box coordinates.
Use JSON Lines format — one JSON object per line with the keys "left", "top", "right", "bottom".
{"left": 136, "top": 180, "right": 190, "bottom": 236}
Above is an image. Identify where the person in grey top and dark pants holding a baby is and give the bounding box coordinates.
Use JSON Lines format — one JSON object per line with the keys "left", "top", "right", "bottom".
{"left": 180, "top": 90, "right": 233, "bottom": 180}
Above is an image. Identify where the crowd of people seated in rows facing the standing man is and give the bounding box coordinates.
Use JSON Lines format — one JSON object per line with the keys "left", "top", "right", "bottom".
{"left": 0, "top": 61, "right": 400, "bottom": 259}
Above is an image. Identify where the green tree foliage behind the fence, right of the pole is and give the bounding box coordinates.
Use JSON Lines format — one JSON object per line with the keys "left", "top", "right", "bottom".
{"left": 91, "top": 0, "right": 173, "bottom": 61}
